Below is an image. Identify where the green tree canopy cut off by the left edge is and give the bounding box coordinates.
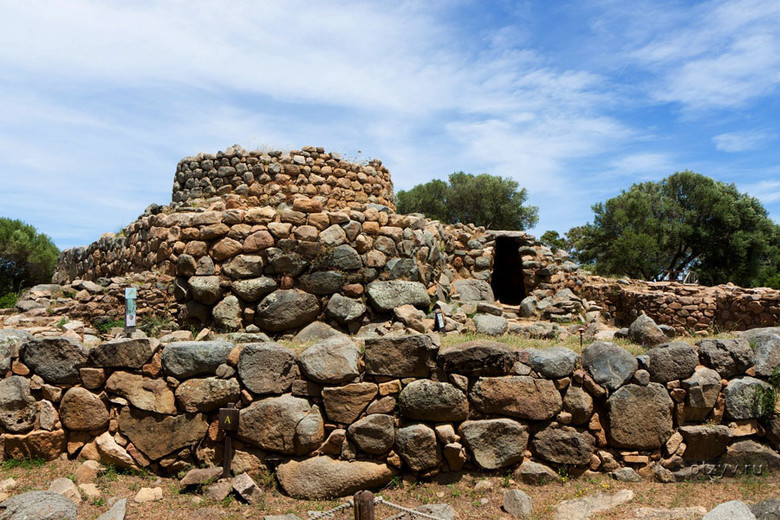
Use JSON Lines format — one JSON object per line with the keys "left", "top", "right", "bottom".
{"left": 0, "top": 218, "right": 60, "bottom": 295}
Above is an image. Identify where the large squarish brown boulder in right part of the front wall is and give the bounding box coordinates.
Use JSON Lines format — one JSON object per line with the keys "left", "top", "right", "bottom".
{"left": 607, "top": 383, "right": 672, "bottom": 450}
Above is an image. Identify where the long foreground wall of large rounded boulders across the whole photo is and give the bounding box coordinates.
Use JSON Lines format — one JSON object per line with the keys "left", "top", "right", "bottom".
{"left": 0, "top": 327, "right": 780, "bottom": 498}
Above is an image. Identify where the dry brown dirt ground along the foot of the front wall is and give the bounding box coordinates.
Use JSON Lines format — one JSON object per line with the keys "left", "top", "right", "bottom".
{"left": 0, "top": 461, "right": 780, "bottom": 520}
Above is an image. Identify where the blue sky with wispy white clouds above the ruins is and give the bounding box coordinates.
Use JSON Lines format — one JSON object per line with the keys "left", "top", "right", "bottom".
{"left": 0, "top": 0, "right": 780, "bottom": 248}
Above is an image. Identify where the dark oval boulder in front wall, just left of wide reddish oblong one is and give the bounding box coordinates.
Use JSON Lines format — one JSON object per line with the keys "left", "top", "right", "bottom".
{"left": 398, "top": 379, "right": 469, "bottom": 422}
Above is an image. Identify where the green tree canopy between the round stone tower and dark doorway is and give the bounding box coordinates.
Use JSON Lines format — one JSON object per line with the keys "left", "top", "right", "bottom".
{"left": 396, "top": 172, "right": 539, "bottom": 229}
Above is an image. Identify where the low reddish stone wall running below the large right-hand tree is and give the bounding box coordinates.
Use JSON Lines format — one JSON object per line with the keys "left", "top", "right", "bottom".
{"left": 578, "top": 277, "right": 780, "bottom": 334}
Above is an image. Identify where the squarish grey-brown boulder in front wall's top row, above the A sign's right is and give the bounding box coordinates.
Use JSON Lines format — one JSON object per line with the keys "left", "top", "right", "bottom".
{"left": 238, "top": 343, "right": 298, "bottom": 395}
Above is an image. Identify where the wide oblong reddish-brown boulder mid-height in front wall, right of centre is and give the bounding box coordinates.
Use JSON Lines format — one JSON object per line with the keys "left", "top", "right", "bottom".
{"left": 471, "top": 376, "right": 563, "bottom": 421}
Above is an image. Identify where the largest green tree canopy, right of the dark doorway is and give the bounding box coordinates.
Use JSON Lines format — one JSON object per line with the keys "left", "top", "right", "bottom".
{"left": 568, "top": 171, "right": 777, "bottom": 285}
